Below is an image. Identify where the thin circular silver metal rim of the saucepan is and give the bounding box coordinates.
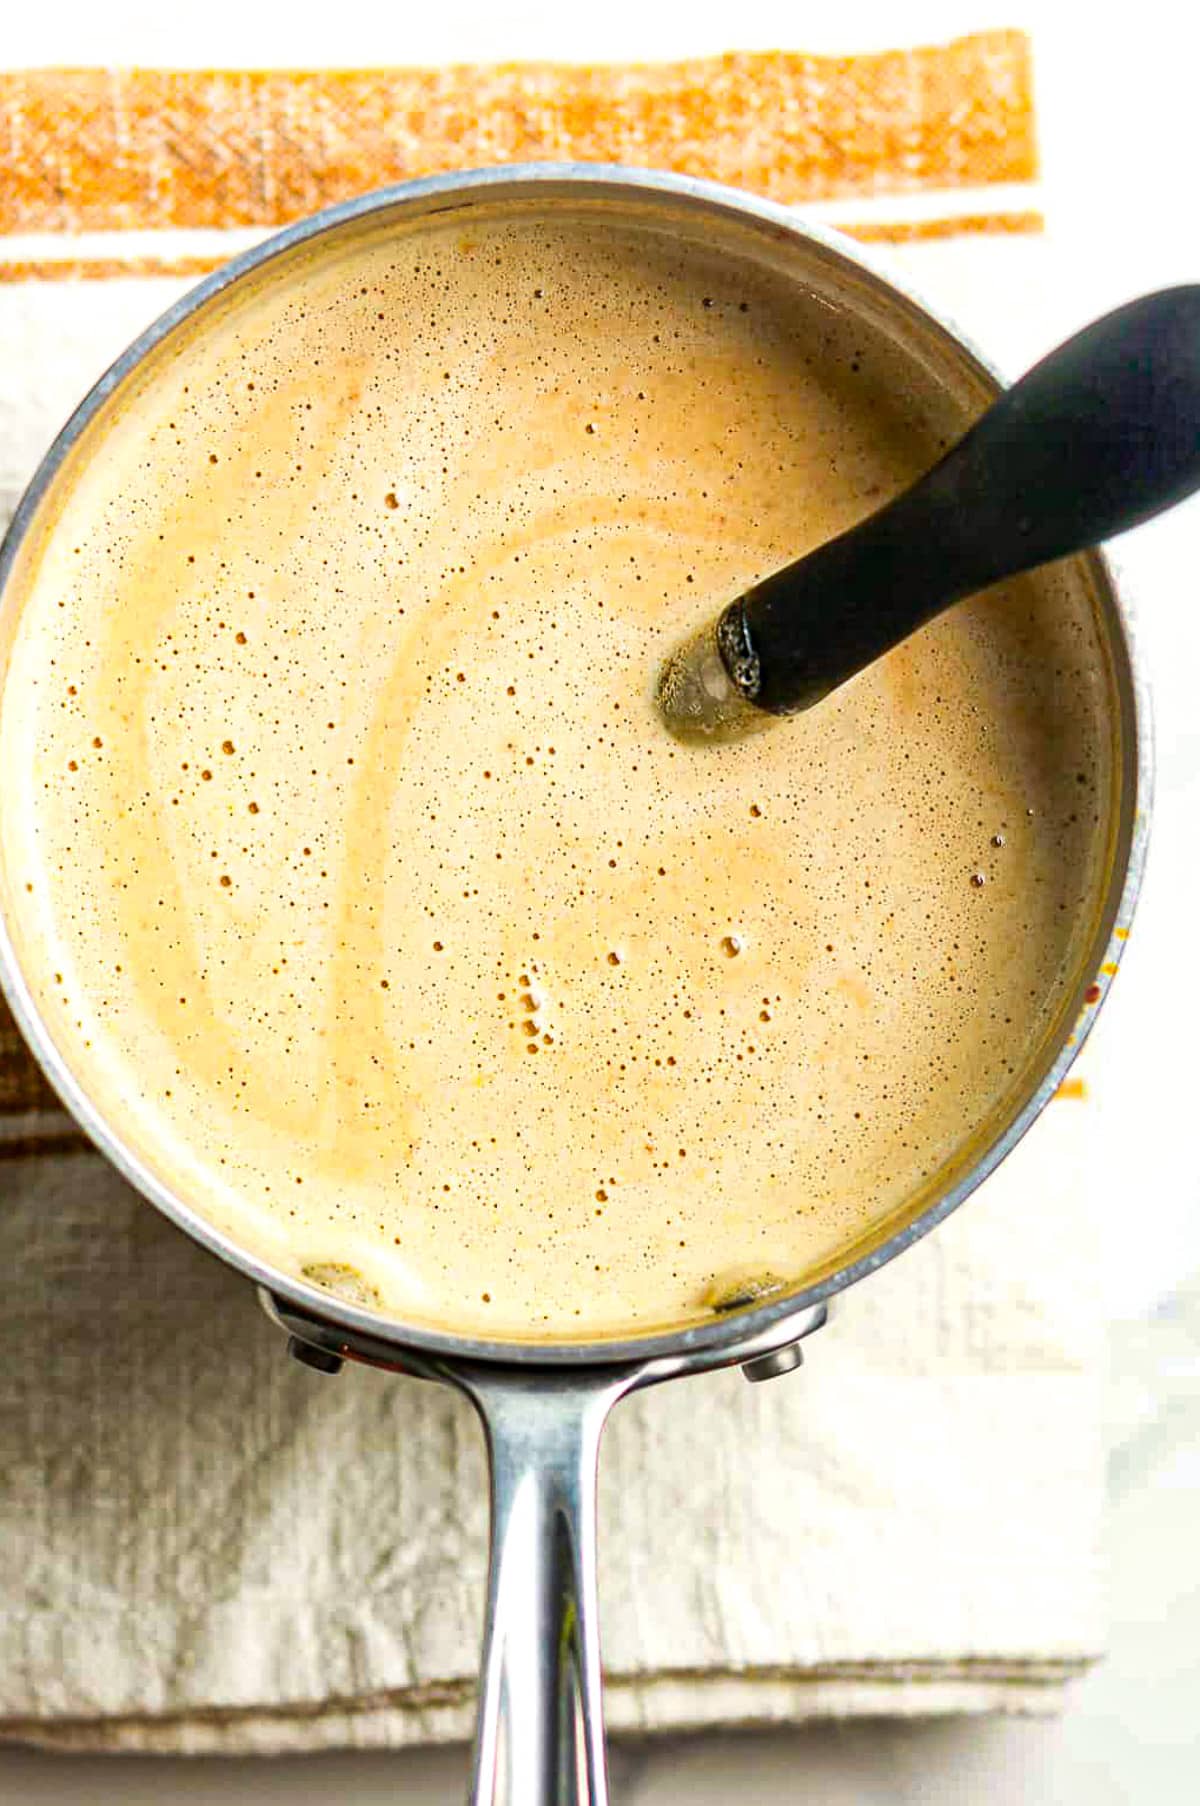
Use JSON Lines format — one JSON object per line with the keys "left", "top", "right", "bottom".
{"left": 0, "top": 163, "right": 1153, "bottom": 1371}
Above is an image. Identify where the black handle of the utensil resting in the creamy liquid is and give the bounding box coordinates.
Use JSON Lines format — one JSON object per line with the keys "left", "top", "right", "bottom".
{"left": 737, "top": 287, "right": 1200, "bottom": 715}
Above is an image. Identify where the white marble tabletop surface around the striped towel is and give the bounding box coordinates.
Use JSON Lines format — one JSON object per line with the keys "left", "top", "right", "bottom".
{"left": 0, "top": 0, "right": 1200, "bottom": 1806}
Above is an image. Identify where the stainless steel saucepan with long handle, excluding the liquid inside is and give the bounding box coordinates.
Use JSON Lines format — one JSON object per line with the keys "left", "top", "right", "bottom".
{"left": 0, "top": 164, "right": 1149, "bottom": 1806}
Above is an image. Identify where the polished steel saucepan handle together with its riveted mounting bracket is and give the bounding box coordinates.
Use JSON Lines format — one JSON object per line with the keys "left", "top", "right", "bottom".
{"left": 258, "top": 1291, "right": 828, "bottom": 1806}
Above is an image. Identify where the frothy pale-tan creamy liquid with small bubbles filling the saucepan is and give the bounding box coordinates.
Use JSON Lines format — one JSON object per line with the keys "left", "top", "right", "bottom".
{"left": 0, "top": 213, "right": 1110, "bottom": 1336}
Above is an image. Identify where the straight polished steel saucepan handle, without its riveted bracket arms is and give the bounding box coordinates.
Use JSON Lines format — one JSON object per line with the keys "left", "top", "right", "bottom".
{"left": 455, "top": 1369, "right": 634, "bottom": 1806}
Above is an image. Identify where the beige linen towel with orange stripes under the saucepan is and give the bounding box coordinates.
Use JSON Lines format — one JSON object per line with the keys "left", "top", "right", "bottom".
{"left": 0, "top": 33, "right": 1101, "bottom": 1750}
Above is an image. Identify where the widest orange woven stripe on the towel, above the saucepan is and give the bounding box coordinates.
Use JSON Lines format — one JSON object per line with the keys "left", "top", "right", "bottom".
{"left": 0, "top": 31, "right": 1037, "bottom": 233}
